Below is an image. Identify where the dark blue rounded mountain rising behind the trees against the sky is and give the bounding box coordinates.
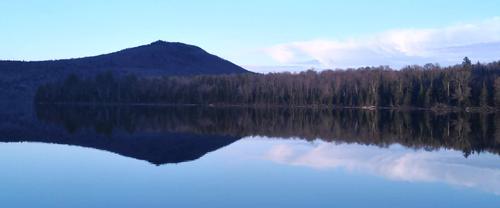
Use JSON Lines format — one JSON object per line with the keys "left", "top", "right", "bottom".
{"left": 0, "top": 41, "right": 249, "bottom": 101}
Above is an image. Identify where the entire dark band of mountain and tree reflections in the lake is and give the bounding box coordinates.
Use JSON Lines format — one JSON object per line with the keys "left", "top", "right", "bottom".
{"left": 0, "top": 105, "right": 500, "bottom": 165}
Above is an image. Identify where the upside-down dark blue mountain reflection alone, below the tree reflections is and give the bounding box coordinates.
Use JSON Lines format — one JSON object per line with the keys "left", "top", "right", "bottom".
{"left": 0, "top": 133, "right": 240, "bottom": 165}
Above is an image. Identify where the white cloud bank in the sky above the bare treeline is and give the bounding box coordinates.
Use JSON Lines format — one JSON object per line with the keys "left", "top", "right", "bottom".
{"left": 265, "top": 17, "right": 500, "bottom": 68}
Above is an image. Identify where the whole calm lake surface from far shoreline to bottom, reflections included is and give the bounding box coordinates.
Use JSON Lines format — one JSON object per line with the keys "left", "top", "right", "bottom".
{"left": 0, "top": 106, "right": 500, "bottom": 208}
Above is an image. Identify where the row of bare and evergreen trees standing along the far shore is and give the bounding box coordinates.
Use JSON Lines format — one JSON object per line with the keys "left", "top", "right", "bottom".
{"left": 35, "top": 58, "right": 500, "bottom": 108}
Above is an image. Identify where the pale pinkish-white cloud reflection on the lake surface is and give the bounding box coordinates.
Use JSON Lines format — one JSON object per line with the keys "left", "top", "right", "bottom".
{"left": 265, "top": 141, "right": 500, "bottom": 195}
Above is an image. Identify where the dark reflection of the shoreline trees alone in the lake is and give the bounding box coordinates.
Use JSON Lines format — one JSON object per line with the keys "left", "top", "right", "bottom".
{"left": 36, "top": 105, "right": 500, "bottom": 156}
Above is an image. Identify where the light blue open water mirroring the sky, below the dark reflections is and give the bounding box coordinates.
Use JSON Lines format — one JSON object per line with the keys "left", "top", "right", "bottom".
{"left": 0, "top": 137, "right": 500, "bottom": 208}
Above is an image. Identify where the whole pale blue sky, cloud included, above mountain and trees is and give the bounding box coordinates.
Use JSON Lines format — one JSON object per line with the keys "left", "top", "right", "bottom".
{"left": 0, "top": 0, "right": 500, "bottom": 71}
